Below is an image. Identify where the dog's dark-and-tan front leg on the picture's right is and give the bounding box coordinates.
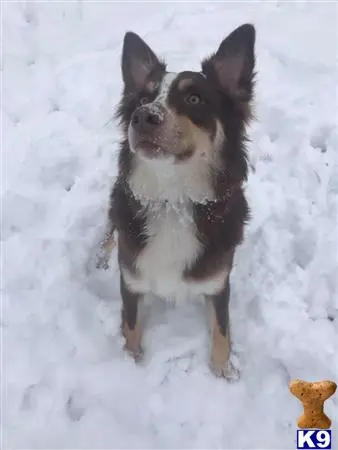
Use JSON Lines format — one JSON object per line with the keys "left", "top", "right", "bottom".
{"left": 206, "top": 278, "right": 240, "bottom": 381}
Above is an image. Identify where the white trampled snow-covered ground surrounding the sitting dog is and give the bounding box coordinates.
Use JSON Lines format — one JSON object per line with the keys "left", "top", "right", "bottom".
{"left": 1, "top": 1, "right": 338, "bottom": 450}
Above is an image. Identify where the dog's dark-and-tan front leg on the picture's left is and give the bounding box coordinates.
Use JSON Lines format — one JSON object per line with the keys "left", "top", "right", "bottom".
{"left": 120, "top": 274, "right": 143, "bottom": 361}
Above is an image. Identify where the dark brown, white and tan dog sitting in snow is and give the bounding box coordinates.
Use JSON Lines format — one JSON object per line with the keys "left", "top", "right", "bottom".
{"left": 97, "top": 24, "right": 256, "bottom": 380}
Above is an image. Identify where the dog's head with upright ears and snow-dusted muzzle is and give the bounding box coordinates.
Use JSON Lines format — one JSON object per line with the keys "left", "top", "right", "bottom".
{"left": 118, "top": 24, "right": 255, "bottom": 191}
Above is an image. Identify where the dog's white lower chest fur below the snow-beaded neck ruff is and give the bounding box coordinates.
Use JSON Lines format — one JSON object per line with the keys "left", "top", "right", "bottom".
{"left": 122, "top": 204, "right": 226, "bottom": 300}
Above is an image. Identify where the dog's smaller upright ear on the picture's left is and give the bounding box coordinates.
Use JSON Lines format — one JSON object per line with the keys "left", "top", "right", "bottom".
{"left": 122, "top": 31, "right": 165, "bottom": 90}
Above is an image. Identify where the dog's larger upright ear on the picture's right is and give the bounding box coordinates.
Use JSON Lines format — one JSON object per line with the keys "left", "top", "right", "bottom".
{"left": 202, "top": 24, "right": 256, "bottom": 96}
